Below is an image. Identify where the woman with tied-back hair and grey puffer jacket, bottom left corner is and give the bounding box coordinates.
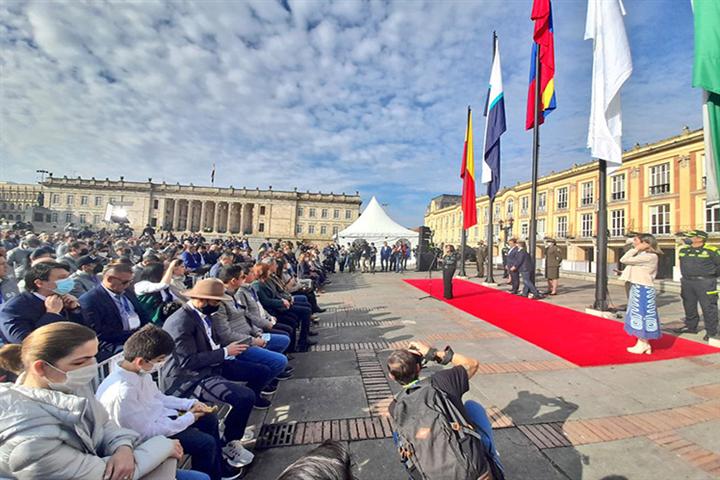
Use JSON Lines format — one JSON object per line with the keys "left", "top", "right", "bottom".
{"left": 0, "top": 322, "right": 182, "bottom": 480}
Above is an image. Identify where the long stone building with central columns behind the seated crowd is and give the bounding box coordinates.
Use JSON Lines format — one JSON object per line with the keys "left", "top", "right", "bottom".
{"left": 6, "top": 177, "right": 361, "bottom": 241}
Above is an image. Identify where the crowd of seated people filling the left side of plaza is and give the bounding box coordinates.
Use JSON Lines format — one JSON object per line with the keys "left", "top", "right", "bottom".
{"left": 0, "top": 227, "right": 336, "bottom": 480}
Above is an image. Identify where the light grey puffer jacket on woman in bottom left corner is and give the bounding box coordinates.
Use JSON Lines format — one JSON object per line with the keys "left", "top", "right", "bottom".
{"left": 0, "top": 375, "right": 174, "bottom": 480}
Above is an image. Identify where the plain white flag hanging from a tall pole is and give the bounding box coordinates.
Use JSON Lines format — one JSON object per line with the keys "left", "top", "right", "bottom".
{"left": 585, "top": 0, "right": 632, "bottom": 167}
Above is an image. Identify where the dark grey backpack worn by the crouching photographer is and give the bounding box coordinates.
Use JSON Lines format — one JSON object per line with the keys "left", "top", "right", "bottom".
{"left": 393, "top": 379, "right": 504, "bottom": 480}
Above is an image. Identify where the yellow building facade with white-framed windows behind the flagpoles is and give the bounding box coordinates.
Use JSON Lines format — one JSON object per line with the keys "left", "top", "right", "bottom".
{"left": 425, "top": 129, "right": 720, "bottom": 278}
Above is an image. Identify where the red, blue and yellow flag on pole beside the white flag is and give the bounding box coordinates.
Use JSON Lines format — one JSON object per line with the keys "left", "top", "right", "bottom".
{"left": 525, "top": 0, "right": 556, "bottom": 130}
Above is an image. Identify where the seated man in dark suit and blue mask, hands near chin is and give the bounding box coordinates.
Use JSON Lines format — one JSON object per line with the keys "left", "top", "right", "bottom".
{"left": 0, "top": 262, "right": 89, "bottom": 343}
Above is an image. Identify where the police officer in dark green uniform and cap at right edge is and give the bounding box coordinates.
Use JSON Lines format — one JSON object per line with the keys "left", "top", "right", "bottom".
{"left": 673, "top": 230, "right": 720, "bottom": 341}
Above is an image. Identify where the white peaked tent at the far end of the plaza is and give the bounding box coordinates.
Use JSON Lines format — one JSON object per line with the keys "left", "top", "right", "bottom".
{"left": 335, "top": 197, "right": 419, "bottom": 260}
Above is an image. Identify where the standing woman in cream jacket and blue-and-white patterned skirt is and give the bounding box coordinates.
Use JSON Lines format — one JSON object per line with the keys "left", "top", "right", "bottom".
{"left": 620, "top": 233, "right": 662, "bottom": 355}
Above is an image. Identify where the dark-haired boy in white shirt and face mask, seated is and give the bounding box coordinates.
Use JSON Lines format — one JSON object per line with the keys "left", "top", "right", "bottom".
{"left": 96, "top": 325, "right": 253, "bottom": 480}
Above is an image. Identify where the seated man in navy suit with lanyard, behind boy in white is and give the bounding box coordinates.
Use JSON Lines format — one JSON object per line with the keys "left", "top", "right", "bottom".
{"left": 80, "top": 263, "right": 150, "bottom": 357}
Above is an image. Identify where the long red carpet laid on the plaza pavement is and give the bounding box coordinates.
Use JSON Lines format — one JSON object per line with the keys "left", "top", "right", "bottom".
{"left": 405, "top": 279, "right": 720, "bottom": 367}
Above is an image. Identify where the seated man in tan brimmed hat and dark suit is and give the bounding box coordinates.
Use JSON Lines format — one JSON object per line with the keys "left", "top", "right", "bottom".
{"left": 163, "top": 278, "right": 256, "bottom": 458}
